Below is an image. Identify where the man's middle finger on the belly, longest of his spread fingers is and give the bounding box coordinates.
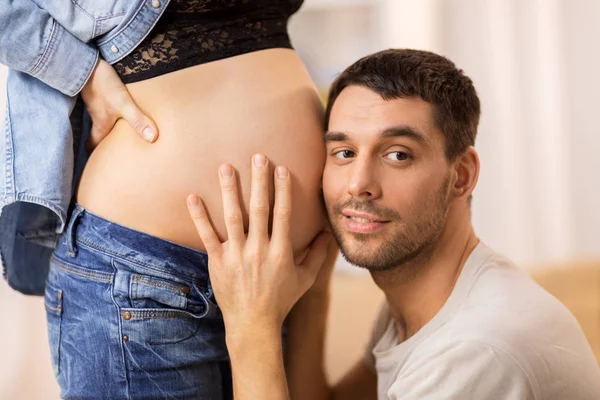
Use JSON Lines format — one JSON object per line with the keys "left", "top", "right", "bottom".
{"left": 248, "top": 154, "right": 270, "bottom": 242}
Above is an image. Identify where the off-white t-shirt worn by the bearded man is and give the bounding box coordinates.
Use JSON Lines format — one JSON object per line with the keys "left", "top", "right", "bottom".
{"left": 366, "top": 243, "right": 600, "bottom": 400}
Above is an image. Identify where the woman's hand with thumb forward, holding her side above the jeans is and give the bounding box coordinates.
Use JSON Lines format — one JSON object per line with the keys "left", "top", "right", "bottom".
{"left": 81, "top": 59, "right": 158, "bottom": 153}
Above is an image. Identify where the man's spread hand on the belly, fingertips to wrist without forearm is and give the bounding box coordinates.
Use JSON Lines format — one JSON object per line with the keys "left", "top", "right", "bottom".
{"left": 188, "top": 155, "right": 332, "bottom": 336}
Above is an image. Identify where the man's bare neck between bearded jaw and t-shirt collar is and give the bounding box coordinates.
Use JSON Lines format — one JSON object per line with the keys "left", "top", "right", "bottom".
{"left": 371, "top": 211, "right": 479, "bottom": 342}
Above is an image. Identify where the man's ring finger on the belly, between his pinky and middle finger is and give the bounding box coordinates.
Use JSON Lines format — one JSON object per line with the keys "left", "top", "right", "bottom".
{"left": 219, "top": 164, "right": 246, "bottom": 249}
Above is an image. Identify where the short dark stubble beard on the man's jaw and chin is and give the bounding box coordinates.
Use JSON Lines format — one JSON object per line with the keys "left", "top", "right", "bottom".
{"left": 330, "top": 177, "right": 450, "bottom": 272}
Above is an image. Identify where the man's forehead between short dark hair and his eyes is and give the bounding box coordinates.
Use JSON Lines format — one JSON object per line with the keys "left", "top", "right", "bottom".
{"left": 328, "top": 86, "right": 437, "bottom": 143}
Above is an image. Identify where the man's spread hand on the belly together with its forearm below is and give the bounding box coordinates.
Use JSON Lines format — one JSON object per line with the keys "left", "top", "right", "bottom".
{"left": 188, "top": 155, "right": 333, "bottom": 400}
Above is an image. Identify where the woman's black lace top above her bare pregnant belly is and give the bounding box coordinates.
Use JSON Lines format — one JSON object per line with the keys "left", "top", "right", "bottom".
{"left": 113, "top": 0, "right": 304, "bottom": 83}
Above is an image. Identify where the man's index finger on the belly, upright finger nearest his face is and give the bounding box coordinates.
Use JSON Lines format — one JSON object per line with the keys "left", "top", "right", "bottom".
{"left": 272, "top": 166, "right": 292, "bottom": 249}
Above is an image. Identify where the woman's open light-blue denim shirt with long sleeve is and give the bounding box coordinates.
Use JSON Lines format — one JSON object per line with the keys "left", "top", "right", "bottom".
{"left": 0, "top": 0, "right": 169, "bottom": 295}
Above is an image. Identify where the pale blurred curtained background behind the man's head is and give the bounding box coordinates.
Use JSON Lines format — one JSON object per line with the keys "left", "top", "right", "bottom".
{"left": 291, "top": 0, "right": 600, "bottom": 267}
